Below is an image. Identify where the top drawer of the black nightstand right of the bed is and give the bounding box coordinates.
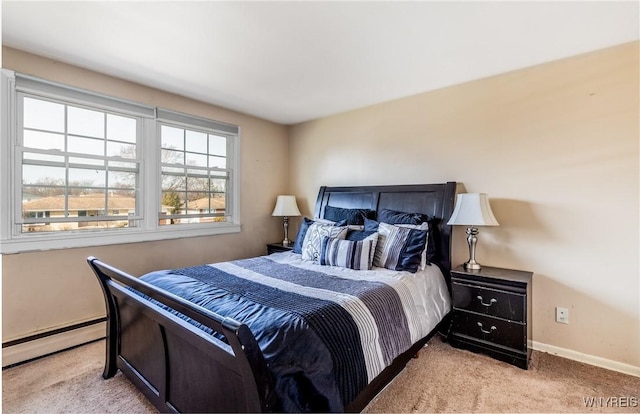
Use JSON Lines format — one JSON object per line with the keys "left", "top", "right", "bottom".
{"left": 452, "top": 281, "right": 526, "bottom": 322}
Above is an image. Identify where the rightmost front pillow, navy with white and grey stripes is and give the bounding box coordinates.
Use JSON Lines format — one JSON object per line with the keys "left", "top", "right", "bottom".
{"left": 373, "top": 223, "right": 429, "bottom": 273}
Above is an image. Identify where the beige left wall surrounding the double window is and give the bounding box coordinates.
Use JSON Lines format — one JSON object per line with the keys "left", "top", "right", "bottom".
{"left": 1, "top": 48, "right": 288, "bottom": 342}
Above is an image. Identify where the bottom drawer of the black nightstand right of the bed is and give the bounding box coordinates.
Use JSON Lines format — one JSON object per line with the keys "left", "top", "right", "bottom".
{"left": 453, "top": 311, "right": 527, "bottom": 351}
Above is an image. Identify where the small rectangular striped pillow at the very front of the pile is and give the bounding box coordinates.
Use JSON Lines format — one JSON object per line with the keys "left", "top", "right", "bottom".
{"left": 320, "top": 233, "right": 378, "bottom": 270}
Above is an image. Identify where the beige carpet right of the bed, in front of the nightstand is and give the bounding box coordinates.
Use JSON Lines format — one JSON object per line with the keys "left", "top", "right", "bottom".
{"left": 365, "top": 338, "right": 640, "bottom": 413}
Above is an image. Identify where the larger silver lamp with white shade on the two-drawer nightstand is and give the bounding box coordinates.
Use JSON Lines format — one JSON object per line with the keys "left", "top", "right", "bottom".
{"left": 447, "top": 193, "right": 500, "bottom": 270}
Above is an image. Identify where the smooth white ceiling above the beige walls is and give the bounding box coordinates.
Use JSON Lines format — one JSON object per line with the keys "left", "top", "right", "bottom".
{"left": 2, "top": 0, "right": 640, "bottom": 124}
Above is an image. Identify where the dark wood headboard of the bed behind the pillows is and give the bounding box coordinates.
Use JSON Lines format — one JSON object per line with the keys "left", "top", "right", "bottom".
{"left": 315, "top": 182, "right": 456, "bottom": 280}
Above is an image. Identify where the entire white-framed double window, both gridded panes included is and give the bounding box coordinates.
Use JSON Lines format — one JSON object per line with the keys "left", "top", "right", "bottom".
{"left": 0, "top": 70, "right": 239, "bottom": 253}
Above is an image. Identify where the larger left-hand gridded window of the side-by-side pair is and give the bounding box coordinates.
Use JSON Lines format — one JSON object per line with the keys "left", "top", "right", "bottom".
{"left": 15, "top": 93, "right": 142, "bottom": 233}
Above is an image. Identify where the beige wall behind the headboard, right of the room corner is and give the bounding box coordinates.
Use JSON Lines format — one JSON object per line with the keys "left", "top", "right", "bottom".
{"left": 289, "top": 43, "right": 640, "bottom": 367}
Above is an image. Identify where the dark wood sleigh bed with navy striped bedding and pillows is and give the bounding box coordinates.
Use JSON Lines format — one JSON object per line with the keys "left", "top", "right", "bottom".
{"left": 87, "top": 182, "right": 456, "bottom": 412}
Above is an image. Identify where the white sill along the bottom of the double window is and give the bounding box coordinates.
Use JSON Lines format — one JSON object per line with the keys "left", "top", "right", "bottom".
{"left": 0, "top": 224, "right": 240, "bottom": 254}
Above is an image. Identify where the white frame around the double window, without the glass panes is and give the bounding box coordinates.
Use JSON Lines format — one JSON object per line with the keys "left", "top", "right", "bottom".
{"left": 0, "top": 69, "right": 241, "bottom": 254}
